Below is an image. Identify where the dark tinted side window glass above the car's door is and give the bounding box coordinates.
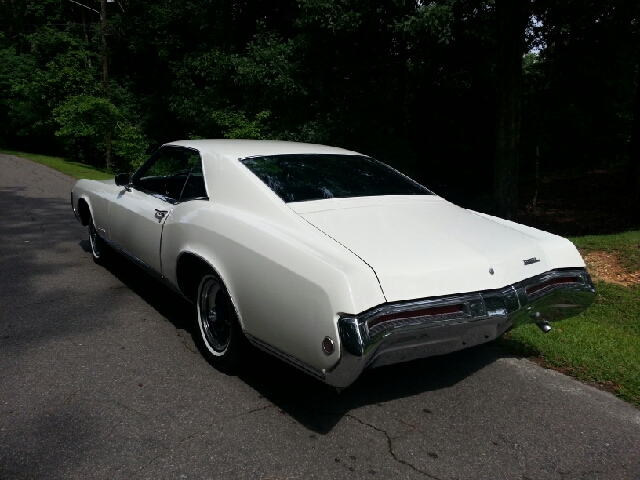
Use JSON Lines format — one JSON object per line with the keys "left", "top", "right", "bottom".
{"left": 133, "top": 147, "right": 207, "bottom": 201}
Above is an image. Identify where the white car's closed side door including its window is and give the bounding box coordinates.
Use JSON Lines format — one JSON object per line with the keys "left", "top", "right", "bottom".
{"left": 109, "top": 146, "right": 206, "bottom": 272}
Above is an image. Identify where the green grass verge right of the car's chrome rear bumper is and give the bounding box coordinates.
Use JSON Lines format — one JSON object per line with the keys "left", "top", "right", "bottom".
{"left": 499, "top": 231, "right": 640, "bottom": 407}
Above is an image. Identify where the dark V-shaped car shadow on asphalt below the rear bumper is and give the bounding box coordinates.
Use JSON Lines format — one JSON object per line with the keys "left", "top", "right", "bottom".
{"left": 238, "top": 345, "right": 507, "bottom": 434}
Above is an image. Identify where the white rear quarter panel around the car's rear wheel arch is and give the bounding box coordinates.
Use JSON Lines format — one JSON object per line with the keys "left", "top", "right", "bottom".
{"left": 162, "top": 201, "right": 384, "bottom": 370}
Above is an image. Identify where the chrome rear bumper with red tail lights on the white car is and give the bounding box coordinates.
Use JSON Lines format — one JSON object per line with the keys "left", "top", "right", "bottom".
{"left": 322, "top": 268, "right": 595, "bottom": 388}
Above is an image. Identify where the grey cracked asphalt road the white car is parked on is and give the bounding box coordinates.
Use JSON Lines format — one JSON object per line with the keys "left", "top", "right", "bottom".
{"left": 0, "top": 155, "right": 640, "bottom": 480}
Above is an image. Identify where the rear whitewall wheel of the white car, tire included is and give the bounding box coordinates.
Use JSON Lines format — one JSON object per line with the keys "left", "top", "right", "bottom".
{"left": 197, "top": 273, "right": 247, "bottom": 372}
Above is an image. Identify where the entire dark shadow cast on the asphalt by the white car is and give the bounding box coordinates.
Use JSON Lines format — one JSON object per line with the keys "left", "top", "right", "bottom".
{"left": 101, "top": 248, "right": 508, "bottom": 435}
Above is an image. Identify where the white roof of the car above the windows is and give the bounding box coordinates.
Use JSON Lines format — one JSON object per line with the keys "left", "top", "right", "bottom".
{"left": 166, "top": 139, "right": 359, "bottom": 158}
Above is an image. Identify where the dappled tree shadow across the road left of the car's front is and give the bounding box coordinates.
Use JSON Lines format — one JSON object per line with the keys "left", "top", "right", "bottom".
{"left": 0, "top": 187, "right": 125, "bottom": 348}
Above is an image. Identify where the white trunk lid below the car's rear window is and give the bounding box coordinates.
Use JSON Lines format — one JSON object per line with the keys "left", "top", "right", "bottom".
{"left": 288, "top": 195, "right": 584, "bottom": 301}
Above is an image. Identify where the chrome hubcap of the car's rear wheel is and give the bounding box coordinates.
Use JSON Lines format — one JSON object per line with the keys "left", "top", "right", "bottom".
{"left": 198, "top": 277, "right": 231, "bottom": 353}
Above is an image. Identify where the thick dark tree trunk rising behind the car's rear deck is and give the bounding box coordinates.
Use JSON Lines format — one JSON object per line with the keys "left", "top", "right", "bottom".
{"left": 493, "top": 0, "right": 528, "bottom": 219}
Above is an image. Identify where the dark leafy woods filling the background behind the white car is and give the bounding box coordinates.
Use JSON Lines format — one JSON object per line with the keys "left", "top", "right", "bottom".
{"left": 0, "top": 0, "right": 640, "bottom": 195}
